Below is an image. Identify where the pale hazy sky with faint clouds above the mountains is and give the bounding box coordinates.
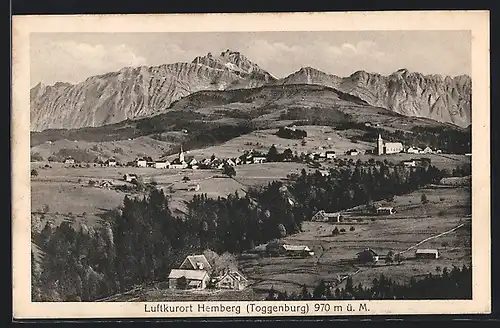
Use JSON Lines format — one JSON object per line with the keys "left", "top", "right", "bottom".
{"left": 30, "top": 31, "right": 471, "bottom": 86}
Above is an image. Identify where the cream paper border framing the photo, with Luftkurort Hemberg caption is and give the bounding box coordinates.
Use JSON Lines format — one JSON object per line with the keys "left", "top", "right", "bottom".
{"left": 11, "top": 11, "right": 491, "bottom": 319}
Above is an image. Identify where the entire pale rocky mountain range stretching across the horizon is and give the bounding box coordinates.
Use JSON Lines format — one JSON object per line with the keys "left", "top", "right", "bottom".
{"left": 30, "top": 49, "right": 472, "bottom": 131}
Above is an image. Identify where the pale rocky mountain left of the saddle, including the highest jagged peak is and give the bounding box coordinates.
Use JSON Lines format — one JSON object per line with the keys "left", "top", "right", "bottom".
{"left": 30, "top": 50, "right": 274, "bottom": 131}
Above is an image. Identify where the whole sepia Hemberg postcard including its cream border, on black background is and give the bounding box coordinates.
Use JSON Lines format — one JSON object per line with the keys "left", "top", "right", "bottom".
{"left": 12, "top": 12, "right": 490, "bottom": 317}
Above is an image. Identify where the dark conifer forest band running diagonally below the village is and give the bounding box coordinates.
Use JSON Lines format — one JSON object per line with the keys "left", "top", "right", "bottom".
{"left": 32, "top": 161, "right": 460, "bottom": 301}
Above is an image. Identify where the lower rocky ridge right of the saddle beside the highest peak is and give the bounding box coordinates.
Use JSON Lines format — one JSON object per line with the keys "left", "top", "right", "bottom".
{"left": 273, "top": 67, "right": 472, "bottom": 127}
